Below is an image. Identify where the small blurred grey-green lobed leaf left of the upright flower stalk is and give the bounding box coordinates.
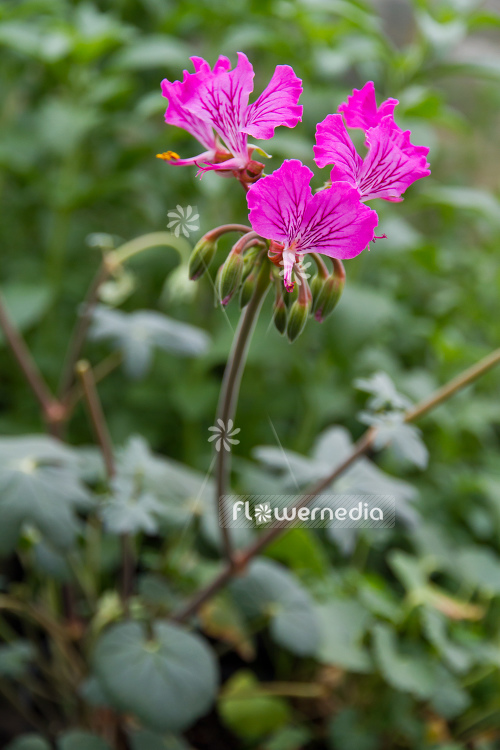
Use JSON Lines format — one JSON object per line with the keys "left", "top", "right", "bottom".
{"left": 89, "top": 305, "right": 210, "bottom": 378}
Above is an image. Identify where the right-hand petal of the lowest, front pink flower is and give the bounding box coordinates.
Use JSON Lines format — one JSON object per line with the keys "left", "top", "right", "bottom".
{"left": 297, "top": 182, "right": 378, "bottom": 259}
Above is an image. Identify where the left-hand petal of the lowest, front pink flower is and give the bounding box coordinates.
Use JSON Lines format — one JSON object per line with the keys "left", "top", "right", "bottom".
{"left": 247, "top": 159, "right": 313, "bottom": 245}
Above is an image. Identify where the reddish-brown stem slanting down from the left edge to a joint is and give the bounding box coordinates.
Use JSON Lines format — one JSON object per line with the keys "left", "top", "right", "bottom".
{"left": 0, "top": 295, "right": 64, "bottom": 426}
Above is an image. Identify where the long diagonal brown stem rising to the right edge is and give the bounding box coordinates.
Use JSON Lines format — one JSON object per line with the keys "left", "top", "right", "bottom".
{"left": 173, "top": 349, "right": 500, "bottom": 622}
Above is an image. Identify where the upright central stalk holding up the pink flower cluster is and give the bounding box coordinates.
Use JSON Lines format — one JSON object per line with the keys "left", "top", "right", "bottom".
{"left": 215, "top": 263, "right": 269, "bottom": 561}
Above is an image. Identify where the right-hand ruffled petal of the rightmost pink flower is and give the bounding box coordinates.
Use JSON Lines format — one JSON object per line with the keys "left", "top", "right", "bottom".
{"left": 358, "top": 115, "right": 430, "bottom": 201}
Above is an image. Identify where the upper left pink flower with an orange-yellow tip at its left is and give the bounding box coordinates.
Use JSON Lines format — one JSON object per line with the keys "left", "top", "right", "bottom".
{"left": 158, "top": 52, "right": 302, "bottom": 184}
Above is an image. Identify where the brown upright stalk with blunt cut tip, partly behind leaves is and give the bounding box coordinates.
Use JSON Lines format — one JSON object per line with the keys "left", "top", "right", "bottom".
{"left": 76, "top": 360, "right": 135, "bottom": 615}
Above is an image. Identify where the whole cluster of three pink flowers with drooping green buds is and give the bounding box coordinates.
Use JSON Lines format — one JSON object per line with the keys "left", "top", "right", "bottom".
{"left": 158, "top": 58, "right": 430, "bottom": 340}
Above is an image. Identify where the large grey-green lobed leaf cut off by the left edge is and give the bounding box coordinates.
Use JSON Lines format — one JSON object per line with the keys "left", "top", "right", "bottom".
{"left": 0, "top": 436, "right": 90, "bottom": 553}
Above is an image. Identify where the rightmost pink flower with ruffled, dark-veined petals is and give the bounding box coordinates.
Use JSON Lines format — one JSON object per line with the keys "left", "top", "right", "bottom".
{"left": 314, "top": 82, "right": 430, "bottom": 201}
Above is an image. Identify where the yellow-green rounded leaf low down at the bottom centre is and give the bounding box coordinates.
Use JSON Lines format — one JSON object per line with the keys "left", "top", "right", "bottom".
{"left": 218, "top": 670, "right": 291, "bottom": 740}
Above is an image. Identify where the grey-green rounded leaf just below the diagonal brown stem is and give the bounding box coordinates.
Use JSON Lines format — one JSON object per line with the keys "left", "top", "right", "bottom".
{"left": 231, "top": 558, "right": 319, "bottom": 656}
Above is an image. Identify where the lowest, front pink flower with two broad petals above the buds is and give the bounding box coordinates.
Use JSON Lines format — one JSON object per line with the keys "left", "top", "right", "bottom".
{"left": 247, "top": 159, "right": 378, "bottom": 291}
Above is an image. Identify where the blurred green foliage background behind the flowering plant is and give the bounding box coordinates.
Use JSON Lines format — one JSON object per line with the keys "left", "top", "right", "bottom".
{"left": 0, "top": 0, "right": 500, "bottom": 750}
